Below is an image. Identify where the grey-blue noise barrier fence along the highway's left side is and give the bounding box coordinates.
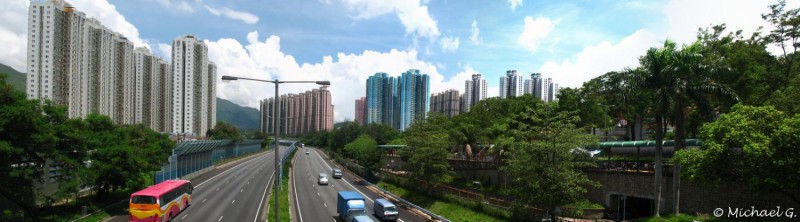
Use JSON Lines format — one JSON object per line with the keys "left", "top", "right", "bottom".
{"left": 154, "top": 140, "right": 262, "bottom": 183}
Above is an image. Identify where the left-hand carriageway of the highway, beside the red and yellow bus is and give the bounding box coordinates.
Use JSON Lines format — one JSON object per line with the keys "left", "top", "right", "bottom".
{"left": 109, "top": 146, "right": 287, "bottom": 222}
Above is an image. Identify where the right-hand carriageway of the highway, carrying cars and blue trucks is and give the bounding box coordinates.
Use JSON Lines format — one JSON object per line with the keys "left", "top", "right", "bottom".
{"left": 290, "top": 148, "right": 427, "bottom": 222}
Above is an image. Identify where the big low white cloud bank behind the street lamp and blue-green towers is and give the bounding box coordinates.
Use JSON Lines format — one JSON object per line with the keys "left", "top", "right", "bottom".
{"left": 206, "top": 32, "right": 464, "bottom": 121}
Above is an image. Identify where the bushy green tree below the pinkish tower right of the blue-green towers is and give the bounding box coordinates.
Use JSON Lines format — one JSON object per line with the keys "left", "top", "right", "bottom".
{"left": 400, "top": 112, "right": 455, "bottom": 193}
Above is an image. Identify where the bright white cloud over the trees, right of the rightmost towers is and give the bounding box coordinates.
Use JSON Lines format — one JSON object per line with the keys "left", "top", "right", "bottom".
{"left": 539, "top": 30, "right": 663, "bottom": 87}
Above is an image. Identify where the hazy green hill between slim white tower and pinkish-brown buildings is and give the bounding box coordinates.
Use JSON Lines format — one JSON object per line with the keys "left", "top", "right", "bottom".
{"left": 217, "top": 98, "right": 261, "bottom": 130}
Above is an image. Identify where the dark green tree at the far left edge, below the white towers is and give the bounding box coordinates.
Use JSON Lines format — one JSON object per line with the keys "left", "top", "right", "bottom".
{"left": 0, "top": 74, "right": 59, "bottom": 220}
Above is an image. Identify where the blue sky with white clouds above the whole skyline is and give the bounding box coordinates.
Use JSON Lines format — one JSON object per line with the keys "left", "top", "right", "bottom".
{"left": 0, "top": 0, "right": 798, "bottom": 121}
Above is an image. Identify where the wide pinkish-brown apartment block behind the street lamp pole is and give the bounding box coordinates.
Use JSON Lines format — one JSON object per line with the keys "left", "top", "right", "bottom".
{"left": 259, "top": 86, "right": 333, "bottom": 136}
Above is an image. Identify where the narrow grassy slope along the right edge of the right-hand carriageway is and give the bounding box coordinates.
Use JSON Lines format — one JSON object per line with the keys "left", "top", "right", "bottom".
{"left": 377, "top": 181, "right": 505, "bottom": 222}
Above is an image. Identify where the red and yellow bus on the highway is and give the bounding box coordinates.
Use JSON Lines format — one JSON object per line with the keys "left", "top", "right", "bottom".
{"left": 128, "top": 180, "right": 194, "bottom": 222}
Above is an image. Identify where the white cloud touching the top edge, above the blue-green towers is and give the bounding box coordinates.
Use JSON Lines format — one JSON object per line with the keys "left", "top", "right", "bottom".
{"left": 342, "top": 0, "right": 440, "bottom": 39}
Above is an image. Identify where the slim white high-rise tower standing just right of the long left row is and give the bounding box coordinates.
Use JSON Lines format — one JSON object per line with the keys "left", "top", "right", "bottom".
{"left": 172, "top": 35, "right": 216, "bottom": 135}
